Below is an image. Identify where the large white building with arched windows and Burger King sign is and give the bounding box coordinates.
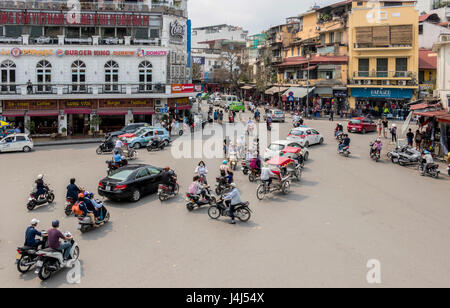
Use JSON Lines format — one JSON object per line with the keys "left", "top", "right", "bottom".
{"left": 0, "top": 0, "right": 194, "bottom": 135}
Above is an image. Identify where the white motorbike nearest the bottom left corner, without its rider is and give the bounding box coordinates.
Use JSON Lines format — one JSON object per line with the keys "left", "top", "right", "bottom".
{"left": 35, "top": 232, "right": 80, "bottom": 281}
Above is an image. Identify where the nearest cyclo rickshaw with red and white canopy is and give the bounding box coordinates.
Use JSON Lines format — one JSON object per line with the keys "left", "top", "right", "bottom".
{"left": 256, "top": 156, "right": 295, "bottom": 200}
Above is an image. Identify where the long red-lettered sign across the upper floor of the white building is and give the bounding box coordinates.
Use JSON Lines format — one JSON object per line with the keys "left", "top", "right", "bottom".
{"left": 0, "top": 11, "right": 151, "bottom": 26}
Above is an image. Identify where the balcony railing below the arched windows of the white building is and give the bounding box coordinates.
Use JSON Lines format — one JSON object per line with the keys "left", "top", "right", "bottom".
{"left": 0, "top": 83, "right": 166, "bottom": 95}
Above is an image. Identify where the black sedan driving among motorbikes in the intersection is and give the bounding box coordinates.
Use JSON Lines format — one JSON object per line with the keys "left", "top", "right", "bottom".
{"left": 98, "top": 165, "right": 169, "bottom": 202}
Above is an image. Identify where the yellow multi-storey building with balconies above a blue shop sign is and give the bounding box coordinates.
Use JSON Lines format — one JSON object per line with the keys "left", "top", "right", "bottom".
{"left": 348, "top": 1, "right": 419, "bottom": 111}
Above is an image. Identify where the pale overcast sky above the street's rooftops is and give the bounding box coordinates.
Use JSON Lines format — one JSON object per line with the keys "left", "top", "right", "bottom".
{"left": 188, "top": 0, "right": 341, "bottom": 35}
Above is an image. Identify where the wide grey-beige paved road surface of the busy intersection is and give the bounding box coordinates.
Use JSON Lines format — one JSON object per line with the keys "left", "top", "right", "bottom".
{"left": 0, "top": 109, "right": 450, "bottom": 288}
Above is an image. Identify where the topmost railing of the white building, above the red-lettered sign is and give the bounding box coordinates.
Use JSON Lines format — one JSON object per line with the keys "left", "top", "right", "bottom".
{"left": 0, "top": 0, "right": 185, "bottom": 16}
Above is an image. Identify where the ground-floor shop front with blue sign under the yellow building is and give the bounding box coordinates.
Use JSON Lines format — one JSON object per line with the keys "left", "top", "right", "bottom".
{"left": 350, "top": 88, "right": 414, "bottom": 120}
